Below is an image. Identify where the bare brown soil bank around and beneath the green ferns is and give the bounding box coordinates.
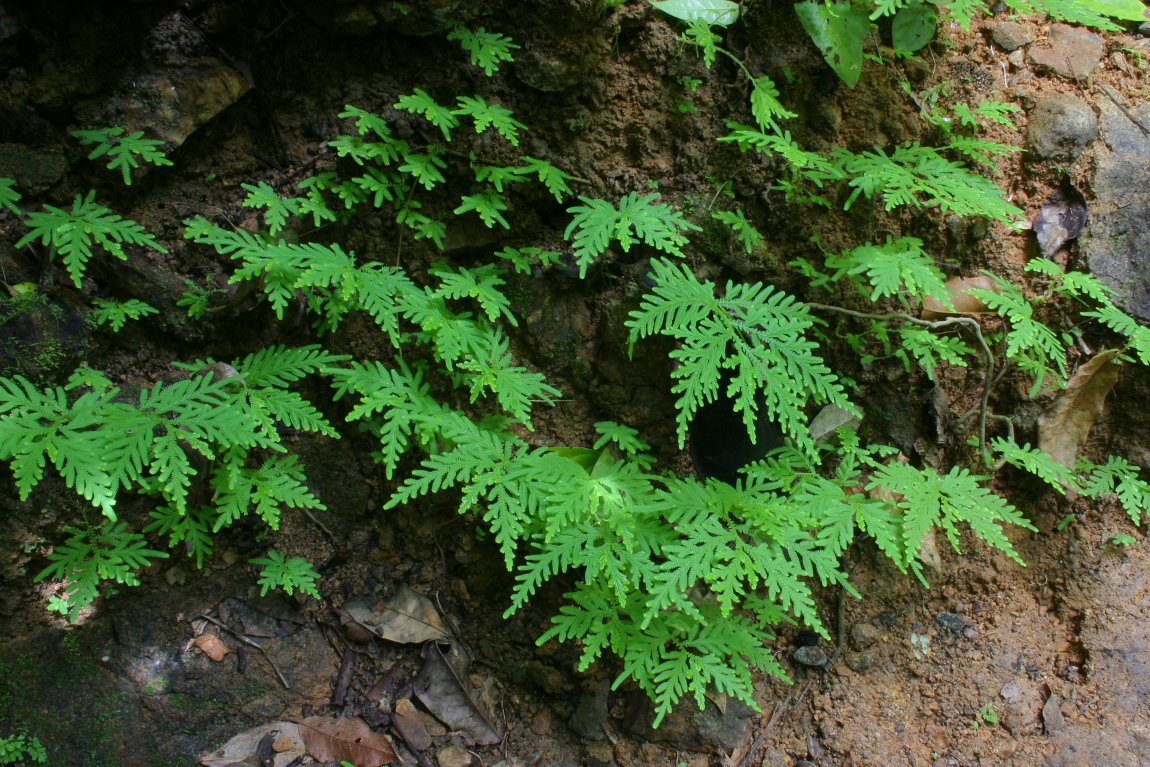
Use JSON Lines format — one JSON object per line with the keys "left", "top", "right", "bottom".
{"left": 0, "top": 0, "right": 1150, "bottom": 767}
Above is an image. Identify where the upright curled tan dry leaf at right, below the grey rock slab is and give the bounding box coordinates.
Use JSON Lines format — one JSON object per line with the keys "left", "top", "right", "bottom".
{"left": 1038, "top": 350, "right": 1118, "bottom": 468}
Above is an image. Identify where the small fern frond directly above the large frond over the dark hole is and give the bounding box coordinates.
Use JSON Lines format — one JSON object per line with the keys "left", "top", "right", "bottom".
{"left": 564, "top": 192, "right": 699, "bottom": 278}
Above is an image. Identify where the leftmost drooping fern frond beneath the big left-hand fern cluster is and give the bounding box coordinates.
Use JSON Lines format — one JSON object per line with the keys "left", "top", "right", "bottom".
{"left": 35, "top": 520, "right": 168, "bottom": 621}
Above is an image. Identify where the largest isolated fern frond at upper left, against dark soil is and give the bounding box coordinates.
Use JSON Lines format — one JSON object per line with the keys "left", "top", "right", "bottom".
{"left": 16, "top": 191, "right": 168, "bottom": 287}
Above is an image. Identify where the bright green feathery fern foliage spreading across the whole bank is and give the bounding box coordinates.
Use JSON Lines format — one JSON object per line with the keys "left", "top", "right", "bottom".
{"left": 0, "top": 0, "right": 1150, "bottom": 723}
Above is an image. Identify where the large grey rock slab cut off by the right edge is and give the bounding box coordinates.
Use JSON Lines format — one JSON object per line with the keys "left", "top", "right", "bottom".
{"left": 1079, "top": 98, "right": 1150, "bottom": 320}
